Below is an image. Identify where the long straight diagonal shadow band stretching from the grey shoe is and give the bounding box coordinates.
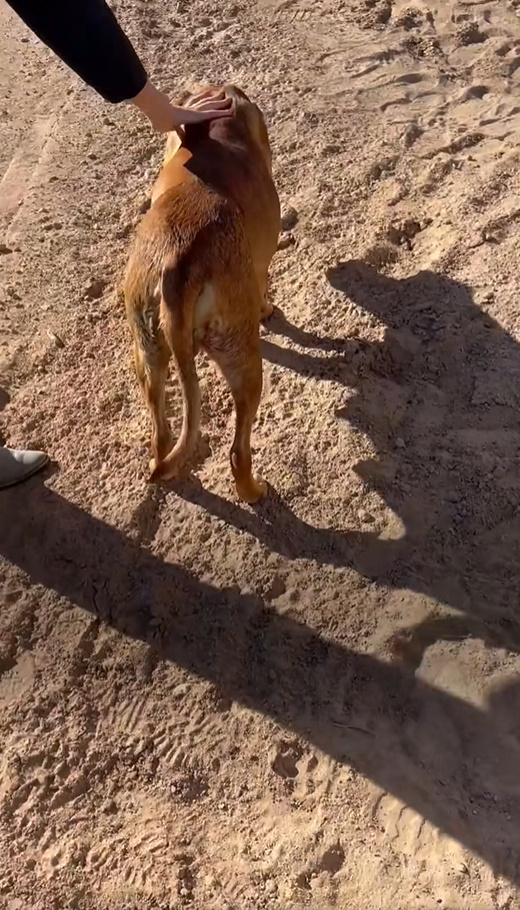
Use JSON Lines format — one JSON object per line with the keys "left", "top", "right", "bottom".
{"left": 0, "top": 478, "right": 520, "bottom": 884}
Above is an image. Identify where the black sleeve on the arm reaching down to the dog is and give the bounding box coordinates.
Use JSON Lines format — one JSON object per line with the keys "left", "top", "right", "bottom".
{"left": 7, "top": 0, "right": 147, "bottom": 103}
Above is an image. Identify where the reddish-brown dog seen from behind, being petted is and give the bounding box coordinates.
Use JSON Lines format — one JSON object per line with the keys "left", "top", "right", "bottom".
{"left": 125, "top": 85, "right": 280, "bottom": 502}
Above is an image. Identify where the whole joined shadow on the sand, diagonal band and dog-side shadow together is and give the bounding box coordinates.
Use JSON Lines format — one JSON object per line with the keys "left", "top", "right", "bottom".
{"left": 0, "top": 263, "right": 520, "bottom": 884}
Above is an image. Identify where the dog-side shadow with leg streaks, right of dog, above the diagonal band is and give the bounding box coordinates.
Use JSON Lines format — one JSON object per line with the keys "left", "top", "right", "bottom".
{"left": 178, "top": 261, "right": 520, "bottom": 667}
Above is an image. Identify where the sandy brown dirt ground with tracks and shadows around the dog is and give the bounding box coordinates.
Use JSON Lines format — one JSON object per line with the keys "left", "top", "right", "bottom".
{"left": 0, "top": 0, "right": 520, "bottom": 910}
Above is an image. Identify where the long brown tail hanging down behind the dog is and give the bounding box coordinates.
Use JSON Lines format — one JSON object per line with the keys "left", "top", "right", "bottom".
{"left": 151, "top": 262, "right": 202, "bottom": 481}
